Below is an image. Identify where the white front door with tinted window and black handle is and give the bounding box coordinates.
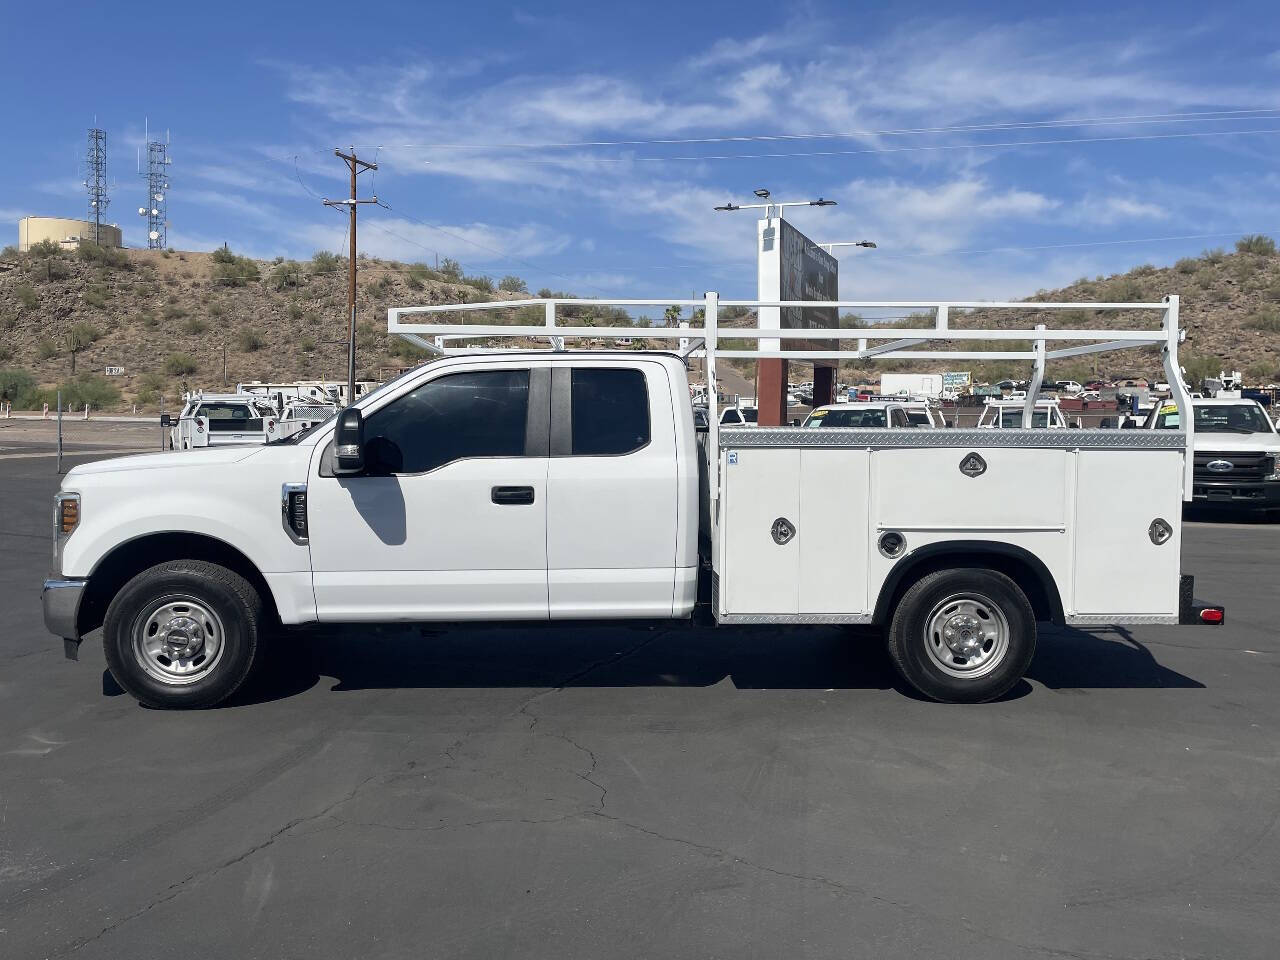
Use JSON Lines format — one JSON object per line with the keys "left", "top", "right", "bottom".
{"left": 307, "top": 364, "right": 550, "bottom": 621}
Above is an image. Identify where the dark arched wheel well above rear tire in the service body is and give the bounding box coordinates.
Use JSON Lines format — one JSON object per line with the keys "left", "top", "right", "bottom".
{"left": 873, "top": 541, "right": 1065, "bottom": 625}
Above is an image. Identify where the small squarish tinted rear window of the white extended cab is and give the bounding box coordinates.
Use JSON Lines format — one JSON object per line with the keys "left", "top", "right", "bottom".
{"left": 571, "top": 367, "right": 649, "bottom": 457}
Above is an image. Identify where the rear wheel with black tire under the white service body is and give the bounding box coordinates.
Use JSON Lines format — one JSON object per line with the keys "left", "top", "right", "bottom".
{"left": 888, "top": 567, "right": 1036, "bottom": 703}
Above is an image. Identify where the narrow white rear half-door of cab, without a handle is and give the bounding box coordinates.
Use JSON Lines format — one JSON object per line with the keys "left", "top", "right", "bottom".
{"left": 547, "top": 360, "right": 678, "bottom": 620}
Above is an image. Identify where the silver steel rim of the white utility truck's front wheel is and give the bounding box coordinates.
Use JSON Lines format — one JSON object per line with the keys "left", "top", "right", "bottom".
{"left": 133, "top": 596, "right": 227, "bottom": 686}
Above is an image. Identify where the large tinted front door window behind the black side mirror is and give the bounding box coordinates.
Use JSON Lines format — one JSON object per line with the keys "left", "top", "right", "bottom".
{"left": 365, "top": 370, "right": 529, "bottom": 476}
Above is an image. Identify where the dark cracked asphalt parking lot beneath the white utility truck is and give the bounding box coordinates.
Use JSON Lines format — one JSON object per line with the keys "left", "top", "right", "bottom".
{"left": 0, "top": 457, "right": 1280, "bottom": 960}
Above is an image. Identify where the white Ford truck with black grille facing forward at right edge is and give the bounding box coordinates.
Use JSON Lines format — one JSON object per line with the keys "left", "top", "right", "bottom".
{"left": 1146, "top": 396, "right": 1280, "bottom": 513}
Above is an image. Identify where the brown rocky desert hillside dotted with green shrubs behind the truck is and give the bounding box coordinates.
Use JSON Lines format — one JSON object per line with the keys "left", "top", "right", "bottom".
{"left": 0, "top": 237, "right": 1280, "bottom": 410}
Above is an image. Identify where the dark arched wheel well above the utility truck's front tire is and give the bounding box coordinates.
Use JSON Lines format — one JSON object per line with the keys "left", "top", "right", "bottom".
{"left": 76, "top": 531, "right": 280, "bottom": 636}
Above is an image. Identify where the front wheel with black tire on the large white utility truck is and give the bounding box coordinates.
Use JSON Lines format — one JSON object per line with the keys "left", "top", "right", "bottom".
{"left": 102, "top": 559, "right": 264, "bottom": 709}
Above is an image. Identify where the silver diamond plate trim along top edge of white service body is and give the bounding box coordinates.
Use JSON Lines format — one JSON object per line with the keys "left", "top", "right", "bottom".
{"left": 719, "top": 426, "right": 1187, "bottom": 451}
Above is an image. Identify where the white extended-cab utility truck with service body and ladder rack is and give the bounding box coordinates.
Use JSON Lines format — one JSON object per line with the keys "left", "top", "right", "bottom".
{"left": 44, "top": 294, "right": 1224, "bottom": 707}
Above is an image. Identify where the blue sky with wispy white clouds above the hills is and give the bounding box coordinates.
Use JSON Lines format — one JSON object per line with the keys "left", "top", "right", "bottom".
{"left": 0, "top": 1, "right": 1280, "bottom": 298}
